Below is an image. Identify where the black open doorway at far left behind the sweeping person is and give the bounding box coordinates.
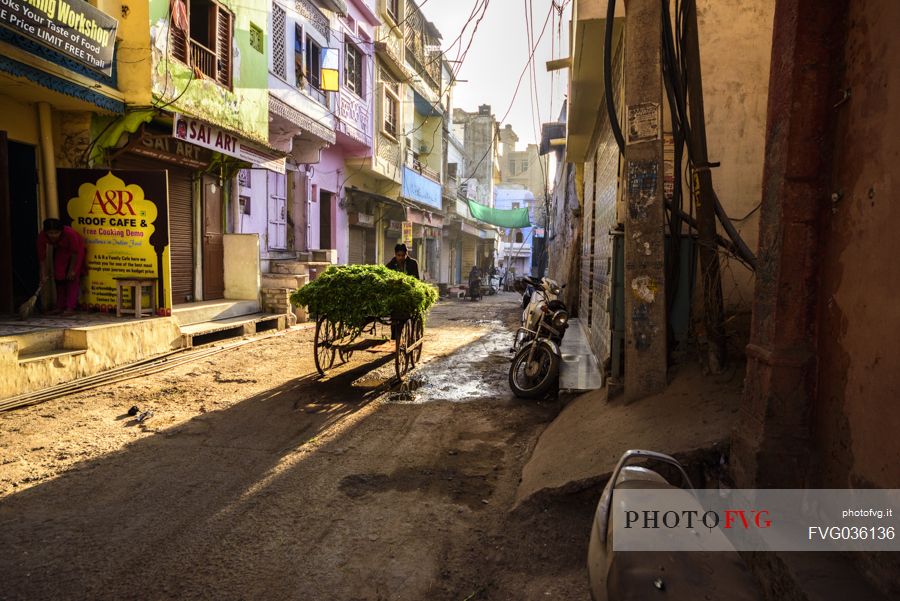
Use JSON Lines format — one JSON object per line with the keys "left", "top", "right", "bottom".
{"left": 0, "top": 137, "right": 40, "bottom": 313}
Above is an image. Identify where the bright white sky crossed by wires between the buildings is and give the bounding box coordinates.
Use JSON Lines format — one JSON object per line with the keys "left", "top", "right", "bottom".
{"left": 419, "top": 0, "right": 571, "bottom": 149}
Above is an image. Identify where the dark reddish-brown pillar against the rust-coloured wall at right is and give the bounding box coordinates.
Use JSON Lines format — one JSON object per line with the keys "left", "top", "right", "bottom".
{"left": 732, "top": 0, "right": 846, "bottom": 488}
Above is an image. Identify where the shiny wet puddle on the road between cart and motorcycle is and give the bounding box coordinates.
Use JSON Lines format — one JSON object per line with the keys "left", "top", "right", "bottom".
{"left": 388, "top": 320, "right": 512, "bottom": 403}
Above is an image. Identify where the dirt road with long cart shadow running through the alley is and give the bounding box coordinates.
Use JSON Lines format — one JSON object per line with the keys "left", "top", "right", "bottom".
{"left": 0, "top": 295, "right": 594, "bottom": 601}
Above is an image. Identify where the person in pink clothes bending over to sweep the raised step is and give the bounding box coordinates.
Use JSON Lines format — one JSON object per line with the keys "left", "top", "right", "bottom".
{"left": 37, "top": 219, "right": 85, "bottom": 315}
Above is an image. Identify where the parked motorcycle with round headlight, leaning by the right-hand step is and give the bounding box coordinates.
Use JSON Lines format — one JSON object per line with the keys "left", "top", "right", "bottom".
{"left": 509, "top": 277, "right": 569, "bottom": 398}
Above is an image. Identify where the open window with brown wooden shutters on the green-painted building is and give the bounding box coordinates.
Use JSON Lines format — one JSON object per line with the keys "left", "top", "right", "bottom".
{"left": 169, "top": 0, "right": 232, "bottom": 88}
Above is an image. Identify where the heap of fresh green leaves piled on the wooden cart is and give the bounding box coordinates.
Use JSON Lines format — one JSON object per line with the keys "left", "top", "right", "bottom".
{"left": 291, "top": 265, "right": 438, "bottom": 328}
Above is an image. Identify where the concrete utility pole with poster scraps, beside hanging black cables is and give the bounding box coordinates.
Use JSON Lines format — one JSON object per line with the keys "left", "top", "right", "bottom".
{"left": 622, "top": 0, "right": 667, "bottom": 401}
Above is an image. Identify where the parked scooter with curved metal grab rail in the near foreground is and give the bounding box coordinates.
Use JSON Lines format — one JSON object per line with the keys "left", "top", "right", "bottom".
{"left": 587, "top": 450, "right": 759, "bottom": 601}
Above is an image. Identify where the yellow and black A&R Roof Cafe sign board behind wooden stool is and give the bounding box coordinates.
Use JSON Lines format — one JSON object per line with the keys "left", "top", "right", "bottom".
{"left": 57, "top": 169, "right": 171, "bottom": 310}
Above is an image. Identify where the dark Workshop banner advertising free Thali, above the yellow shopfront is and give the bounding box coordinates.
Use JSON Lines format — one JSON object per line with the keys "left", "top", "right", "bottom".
{"left": 0, "top": 0, "right": 119, "bottom": 75}
